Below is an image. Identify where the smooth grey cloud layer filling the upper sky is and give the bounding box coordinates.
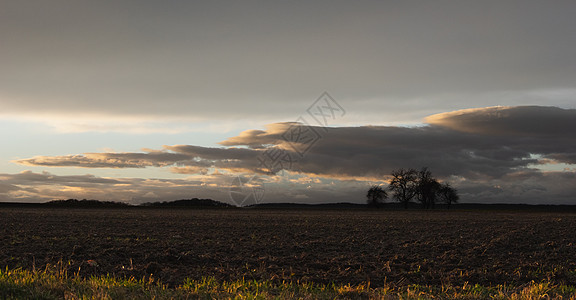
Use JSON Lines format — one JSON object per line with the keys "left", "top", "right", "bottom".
{"left": 0, "top": 0, "right": 576, "bottom": 121}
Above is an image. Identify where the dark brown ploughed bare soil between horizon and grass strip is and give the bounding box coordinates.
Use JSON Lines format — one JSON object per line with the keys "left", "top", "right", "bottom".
{"left": 0, "top": 208, "right": 576, "bottom": 286}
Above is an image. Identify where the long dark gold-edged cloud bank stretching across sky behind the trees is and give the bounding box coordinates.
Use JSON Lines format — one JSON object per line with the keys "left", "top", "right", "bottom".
{"left": 12, "top": 106, "right": 576, "bottom": 201}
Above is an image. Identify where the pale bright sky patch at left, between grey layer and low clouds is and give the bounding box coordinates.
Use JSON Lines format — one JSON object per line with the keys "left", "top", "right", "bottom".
{"left": 0, "top": 119, "right": 245, "bottom": 178}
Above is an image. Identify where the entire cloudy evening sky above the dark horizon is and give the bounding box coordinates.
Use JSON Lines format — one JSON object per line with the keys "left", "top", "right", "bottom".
{"left": 0, "top": 0, "right": 576, "bottom": 205}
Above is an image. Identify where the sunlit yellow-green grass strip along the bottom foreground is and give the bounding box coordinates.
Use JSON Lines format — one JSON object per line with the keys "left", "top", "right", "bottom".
{"left": 0, "top": 265, "right": 576, "bottom": 299}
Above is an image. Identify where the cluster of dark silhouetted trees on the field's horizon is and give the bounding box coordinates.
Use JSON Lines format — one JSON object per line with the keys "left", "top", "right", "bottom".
{"left": 366, "top": 168, "right": 460, "bottom": 209}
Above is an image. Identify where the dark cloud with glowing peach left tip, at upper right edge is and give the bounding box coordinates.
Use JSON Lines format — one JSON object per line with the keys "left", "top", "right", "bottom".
{"left": 426, "top": 106, "right": 576, "bottom": 164}
